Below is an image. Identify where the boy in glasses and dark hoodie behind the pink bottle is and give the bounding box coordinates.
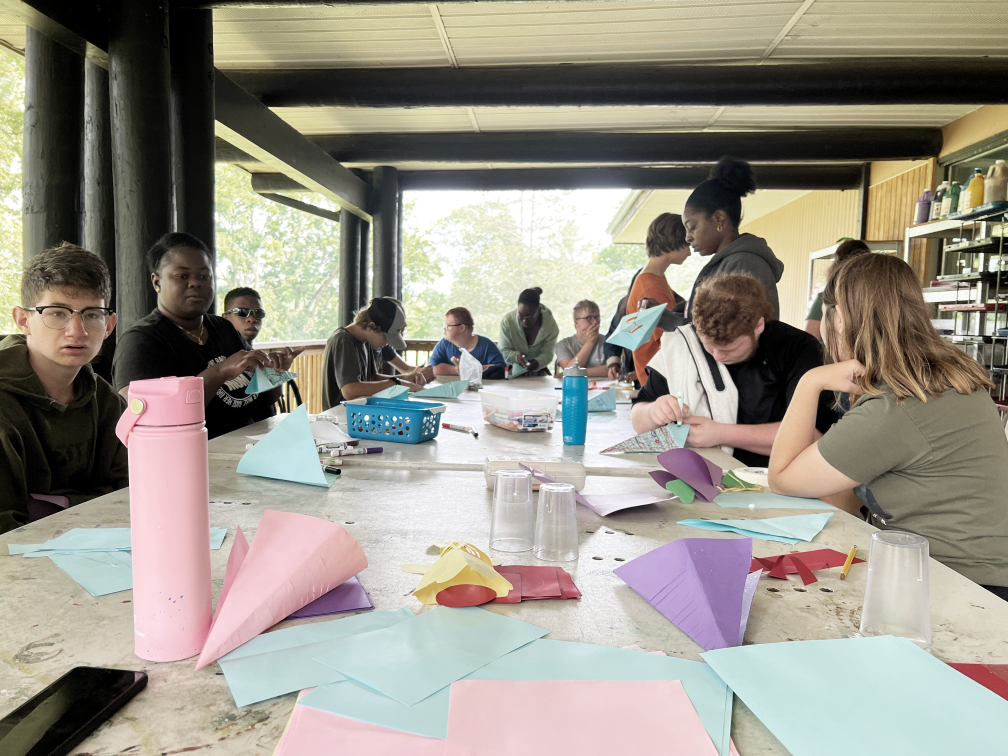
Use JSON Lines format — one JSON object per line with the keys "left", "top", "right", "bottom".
{"left": 0, "top": 242, "right": 129, "bottom": 533}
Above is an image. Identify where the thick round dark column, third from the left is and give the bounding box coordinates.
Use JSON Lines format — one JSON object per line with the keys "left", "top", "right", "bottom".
{"left": 108, "top": 0, "right": 173, "bottom": 334}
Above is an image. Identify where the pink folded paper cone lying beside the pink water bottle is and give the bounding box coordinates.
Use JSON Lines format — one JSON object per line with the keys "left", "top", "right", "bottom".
{"left": 196, "top": 510, "right": 368, "bottom": 669}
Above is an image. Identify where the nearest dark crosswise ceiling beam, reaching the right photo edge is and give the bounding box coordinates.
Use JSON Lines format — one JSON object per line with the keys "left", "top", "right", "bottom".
{"left": 228, "top": 57, "right": 1008, "bottom": 108}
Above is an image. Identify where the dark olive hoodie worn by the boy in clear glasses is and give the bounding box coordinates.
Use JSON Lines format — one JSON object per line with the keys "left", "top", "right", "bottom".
{"left": 0, "top": 336, "right": 129, "bottom": 533}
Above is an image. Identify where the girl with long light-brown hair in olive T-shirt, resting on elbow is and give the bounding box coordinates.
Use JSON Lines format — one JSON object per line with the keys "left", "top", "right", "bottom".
{"left": 769, "top": 255, "right": 1008, "bottom": 600}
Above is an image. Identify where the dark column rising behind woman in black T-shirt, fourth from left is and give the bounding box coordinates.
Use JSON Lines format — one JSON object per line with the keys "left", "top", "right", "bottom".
{"left": 170, "top": 10, "right": 216, "bottom": 257}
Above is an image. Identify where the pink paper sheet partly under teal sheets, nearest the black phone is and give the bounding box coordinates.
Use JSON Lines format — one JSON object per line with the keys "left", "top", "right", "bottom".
{"left": 273, "top": 706, "right": 445, "bottom": 756}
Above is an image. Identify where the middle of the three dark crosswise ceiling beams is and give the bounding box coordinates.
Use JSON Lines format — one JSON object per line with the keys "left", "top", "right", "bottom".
{"left": 310, "top": 128, "right": 941, "bottom": 165}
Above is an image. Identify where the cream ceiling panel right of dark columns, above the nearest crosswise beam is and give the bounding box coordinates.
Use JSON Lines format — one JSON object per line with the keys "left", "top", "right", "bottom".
{"left": 214, "top": 5, "right": 448, "bottom": 70}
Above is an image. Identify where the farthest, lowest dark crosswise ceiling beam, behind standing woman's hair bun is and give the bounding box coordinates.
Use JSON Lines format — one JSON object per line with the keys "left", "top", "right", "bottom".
{"left": 252, "top": 163, "right": 862, "bottom": 194}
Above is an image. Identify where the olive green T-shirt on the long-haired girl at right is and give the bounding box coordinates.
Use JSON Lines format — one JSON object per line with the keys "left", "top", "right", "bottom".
{"left": 818, "top": 389, "right": 1008, "bottom": 586}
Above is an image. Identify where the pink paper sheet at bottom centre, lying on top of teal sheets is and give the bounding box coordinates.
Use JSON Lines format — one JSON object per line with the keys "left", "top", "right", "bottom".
{"left": 445, "top": 679, "right": 718, "bottom": 756}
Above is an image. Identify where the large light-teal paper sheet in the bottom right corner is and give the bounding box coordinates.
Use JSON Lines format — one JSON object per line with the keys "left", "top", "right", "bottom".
{"left": 701, "top": 636, "right": 1008, "bottom": 756}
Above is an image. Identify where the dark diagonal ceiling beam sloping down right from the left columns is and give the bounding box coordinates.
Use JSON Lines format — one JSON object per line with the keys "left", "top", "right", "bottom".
{"left": 215, "top": 71, "right": 371, "bottom": 221}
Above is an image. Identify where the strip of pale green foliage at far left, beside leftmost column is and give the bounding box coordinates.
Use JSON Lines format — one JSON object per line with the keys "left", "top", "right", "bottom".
{"left": 0, "top": 51, "right": 24, "bottom": 333}
